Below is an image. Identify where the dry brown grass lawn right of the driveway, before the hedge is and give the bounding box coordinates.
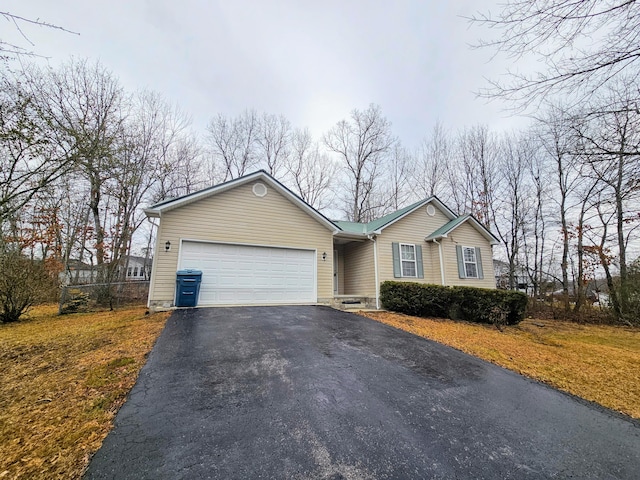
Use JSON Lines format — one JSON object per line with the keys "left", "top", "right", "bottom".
{"left": 361, "top": 312, "right": 640, "bottom": 418}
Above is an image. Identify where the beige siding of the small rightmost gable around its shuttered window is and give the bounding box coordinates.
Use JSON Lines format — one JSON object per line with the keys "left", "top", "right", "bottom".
{"left": 442, "top": 223, "right": 496, "bottom": 288}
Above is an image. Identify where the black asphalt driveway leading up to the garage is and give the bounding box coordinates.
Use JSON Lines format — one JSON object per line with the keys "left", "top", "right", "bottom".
{"left": 86, "top": 307, "right": 640, "bottom": 479}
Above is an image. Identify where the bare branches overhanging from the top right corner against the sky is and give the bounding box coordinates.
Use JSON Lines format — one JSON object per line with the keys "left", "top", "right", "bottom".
{"left": 470, "top": 0, "right": 640, "bottom": 107}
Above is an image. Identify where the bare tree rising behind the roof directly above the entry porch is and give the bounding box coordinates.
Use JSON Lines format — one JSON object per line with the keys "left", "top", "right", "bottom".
{"left": 324, "top": 105, "right": 396, "bottom": 222}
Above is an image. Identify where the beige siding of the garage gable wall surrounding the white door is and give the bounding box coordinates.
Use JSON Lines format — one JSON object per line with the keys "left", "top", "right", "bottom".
{"left": 149, "top": 182, "right": 333, "bottom": 305}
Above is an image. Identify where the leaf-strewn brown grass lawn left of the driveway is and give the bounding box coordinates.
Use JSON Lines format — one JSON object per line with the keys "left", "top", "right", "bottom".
{"left": 0, "top": 306, "right": 168, "bottom": 479}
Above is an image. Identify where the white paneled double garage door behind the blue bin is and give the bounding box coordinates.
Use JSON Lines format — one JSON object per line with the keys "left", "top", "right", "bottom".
{"left": 180, "top": 241, "right": 317, "bottom": 305}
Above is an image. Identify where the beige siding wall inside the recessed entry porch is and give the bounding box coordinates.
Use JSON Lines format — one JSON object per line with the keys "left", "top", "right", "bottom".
{"left": 344, "top": 240, "right": 376, "bottom": 297}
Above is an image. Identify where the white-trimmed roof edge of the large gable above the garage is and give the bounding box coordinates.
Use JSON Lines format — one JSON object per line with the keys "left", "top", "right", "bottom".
{"left": 144, "top": 170, "right": 340, "bottom": 233}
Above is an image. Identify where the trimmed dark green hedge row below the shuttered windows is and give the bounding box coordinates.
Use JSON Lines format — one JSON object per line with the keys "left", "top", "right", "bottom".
{"left": 380, "top": 281, "right": 527, "bottom": 325}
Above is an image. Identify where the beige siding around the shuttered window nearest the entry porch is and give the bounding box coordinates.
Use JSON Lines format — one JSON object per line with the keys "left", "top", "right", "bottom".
{"left": 378, "top": 205, "right": 449, "bottom": 284}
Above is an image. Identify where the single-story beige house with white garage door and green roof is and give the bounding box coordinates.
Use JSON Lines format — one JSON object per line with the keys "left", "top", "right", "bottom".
{"left": 145, "top": 171, "right": 498, "bottom": 308}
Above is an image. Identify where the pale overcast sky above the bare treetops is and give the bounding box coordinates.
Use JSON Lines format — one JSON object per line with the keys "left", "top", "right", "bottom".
{"left": 0, "top": 0, "right": 524, "bottom": 148}
